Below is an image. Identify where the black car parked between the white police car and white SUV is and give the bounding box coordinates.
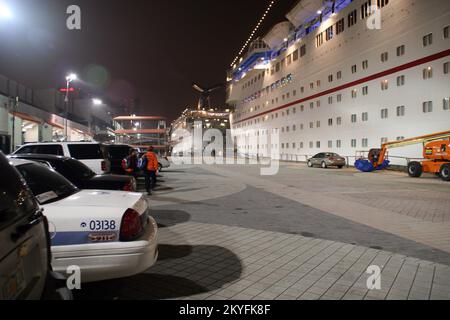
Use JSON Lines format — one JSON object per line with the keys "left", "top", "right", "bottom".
{"left": 10, "top": 154, "right": 137, "bottom": 192}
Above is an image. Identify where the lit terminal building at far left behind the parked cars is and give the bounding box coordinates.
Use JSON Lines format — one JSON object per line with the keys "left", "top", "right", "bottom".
{"left": 0, "top": 75, "right": 114, "bottom": 154}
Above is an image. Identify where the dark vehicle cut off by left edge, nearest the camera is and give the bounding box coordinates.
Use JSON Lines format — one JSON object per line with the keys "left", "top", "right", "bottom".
{"left": 0, "top": 152, "right": 72, "bottom": 300}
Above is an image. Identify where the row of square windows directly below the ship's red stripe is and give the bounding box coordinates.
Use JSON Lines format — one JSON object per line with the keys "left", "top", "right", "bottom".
{"left": 234, "top": 62, "right": 449, "bottom": 126}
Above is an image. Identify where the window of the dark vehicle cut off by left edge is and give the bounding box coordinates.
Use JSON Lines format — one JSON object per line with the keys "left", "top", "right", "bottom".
{"left": 0, "top": 153, "right": 38, "bottom": 230}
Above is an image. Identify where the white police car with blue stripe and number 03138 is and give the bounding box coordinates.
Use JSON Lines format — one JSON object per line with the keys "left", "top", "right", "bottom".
{"left": 11, "top": 159, "right": 158, "bottom": 282}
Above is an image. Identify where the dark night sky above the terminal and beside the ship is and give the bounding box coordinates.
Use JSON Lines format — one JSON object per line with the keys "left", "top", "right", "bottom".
{"left": 0, "top": 0, "right": 296, "bottom": 119}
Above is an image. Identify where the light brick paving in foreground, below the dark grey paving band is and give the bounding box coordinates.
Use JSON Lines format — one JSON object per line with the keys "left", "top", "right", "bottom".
{"left": 78, "top": 222, "right": 450, "bottom": 300}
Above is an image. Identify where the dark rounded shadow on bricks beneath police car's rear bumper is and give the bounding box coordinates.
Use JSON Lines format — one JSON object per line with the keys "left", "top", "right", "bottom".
{"left": 75, "top": 245, "right": 242, "bottom": 300}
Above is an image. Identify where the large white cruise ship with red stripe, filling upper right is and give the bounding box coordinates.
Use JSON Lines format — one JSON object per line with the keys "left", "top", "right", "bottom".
{"left": 227, "top": 0, "right": 450, "bottom": 165}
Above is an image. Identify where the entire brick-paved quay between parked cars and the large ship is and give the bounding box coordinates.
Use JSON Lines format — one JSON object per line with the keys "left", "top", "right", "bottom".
{"left": 77, "top": 164, "right": 450, "bottom": 300}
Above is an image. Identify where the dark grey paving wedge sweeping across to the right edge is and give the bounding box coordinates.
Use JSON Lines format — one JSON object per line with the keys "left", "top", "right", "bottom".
{"left": 157, "top": 186, "right": 450, "bottom": 266}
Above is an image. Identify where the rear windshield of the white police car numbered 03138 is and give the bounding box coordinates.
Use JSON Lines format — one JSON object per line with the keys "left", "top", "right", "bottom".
{"left": 17, "top": 163, "right": 79, "bottom": 204}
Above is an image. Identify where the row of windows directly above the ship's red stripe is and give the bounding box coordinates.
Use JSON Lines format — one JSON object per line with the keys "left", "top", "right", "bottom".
{"left": 237, "top": 31, "right": 449, "bottom": 117}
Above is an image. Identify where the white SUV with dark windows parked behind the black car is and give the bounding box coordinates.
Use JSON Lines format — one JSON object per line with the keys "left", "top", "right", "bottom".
{"left": 13, "top": 142, "right": 106, "bottom": 174}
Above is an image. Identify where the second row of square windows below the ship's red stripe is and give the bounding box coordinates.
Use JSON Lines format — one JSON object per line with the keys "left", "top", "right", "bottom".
{"left": 234, "top": 97, "right": 450, "bottom": 135}
